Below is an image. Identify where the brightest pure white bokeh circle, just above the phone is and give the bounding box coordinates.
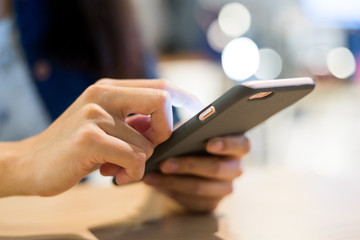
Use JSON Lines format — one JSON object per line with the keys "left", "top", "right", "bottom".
{"left": 221, "top": 37, "right": 260, "bottom": 81}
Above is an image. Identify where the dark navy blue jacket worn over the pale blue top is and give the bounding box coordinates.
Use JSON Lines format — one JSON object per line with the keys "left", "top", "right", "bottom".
{"left": 14, "top": 0, "right": 96, "bottom": 120}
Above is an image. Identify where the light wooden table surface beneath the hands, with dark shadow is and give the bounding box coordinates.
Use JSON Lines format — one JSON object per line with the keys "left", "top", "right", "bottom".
{"left": 0, "top": 167, "right": 360, "bottom": 240}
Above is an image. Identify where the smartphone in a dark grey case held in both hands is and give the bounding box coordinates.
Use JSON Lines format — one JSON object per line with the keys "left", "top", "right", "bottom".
{"left": 145, "top": 78, "right": 315, "bottom": 173}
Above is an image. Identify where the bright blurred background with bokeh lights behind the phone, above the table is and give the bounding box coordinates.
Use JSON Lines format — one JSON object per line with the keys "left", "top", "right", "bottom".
{"left": 127, "top": 0, "right": 360, "bottom": 178}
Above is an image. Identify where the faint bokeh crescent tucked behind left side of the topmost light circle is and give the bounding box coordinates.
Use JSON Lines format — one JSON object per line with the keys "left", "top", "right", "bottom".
{"left": 207, "top": 20, "right": 232, "bottom": 52}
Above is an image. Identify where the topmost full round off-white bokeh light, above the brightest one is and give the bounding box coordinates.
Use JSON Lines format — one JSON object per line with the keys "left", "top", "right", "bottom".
{"left": 218, "top": 2, "right": 251, "bottom": 37}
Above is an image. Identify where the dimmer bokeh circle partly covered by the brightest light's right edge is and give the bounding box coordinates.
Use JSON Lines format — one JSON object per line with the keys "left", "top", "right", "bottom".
{"left": 255, "top": 48, "right": 282, "bottom": 79}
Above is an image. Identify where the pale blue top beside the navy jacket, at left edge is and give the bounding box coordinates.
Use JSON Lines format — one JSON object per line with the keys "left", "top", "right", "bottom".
{"left": 0, "top": 17, "right": 51, "bottom": 141}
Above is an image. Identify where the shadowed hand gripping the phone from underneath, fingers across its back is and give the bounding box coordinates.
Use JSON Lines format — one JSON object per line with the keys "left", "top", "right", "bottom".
{"left": 144, "top": 135, "right": 250, "bottom": 212}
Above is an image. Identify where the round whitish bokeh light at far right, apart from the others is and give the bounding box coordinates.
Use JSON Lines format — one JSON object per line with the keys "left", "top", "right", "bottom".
{"left": 326, "top": 47, "right": 356, "bottom": 79}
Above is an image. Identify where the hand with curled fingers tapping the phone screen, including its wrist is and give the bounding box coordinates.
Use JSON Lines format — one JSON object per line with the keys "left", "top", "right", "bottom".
{"left": 0, "top": 80, "right": 197, "bottom": 196}
